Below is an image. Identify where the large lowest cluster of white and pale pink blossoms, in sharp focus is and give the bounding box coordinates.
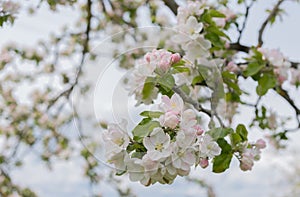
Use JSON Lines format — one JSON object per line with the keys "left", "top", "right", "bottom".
{"left": 104, "top": 94, "right": 221, "bottom": 185}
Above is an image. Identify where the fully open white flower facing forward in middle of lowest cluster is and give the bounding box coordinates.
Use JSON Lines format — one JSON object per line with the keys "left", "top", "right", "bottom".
{"left": 143, "top": 128, "right": 172, "bottom": 161}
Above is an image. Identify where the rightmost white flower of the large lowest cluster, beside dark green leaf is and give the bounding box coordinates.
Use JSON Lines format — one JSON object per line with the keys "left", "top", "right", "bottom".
{"left": 199, "top": 134, "right": 222, "bottom": 158}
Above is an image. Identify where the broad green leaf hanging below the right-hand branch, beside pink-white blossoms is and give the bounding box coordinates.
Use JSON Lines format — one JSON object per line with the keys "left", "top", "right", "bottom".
{"left": 256, "top": 73, "right": 277, "bottom": 96}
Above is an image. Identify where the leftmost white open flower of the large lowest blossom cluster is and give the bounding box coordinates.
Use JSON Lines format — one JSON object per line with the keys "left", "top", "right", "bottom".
{"left": 103, "top": 121, "right": 129, "bottom": 159}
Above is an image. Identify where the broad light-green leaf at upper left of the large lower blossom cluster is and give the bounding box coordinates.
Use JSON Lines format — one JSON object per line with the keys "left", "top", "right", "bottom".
{"left": 132, "top": 118, "right": 160, "bottom": 142}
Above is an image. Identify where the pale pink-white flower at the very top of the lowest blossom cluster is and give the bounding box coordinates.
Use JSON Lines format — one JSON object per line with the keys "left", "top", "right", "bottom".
{"left": 160, "top": 94, "right": 183, "bottom": 114}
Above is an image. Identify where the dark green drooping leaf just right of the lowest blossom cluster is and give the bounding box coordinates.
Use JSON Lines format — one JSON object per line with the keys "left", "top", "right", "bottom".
{"left": 213, "top": 139, "right": 233, "bottom": 173}
